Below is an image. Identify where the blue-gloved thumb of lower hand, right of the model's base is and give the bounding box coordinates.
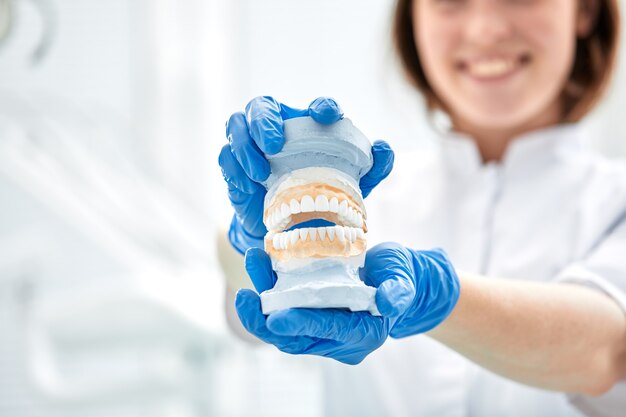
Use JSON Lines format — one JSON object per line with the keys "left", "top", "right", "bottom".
{"left": 359, "top": 242, "right": 416, "bottom": 317}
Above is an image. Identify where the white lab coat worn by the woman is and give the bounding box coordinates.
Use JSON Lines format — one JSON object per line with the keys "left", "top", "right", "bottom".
{"left": 324, "top": 125, "right": 626, "bottom": 417}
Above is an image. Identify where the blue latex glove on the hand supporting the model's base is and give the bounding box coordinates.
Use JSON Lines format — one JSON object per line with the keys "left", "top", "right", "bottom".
{"left": 235, "top": 243, "right": 459, "bottom": 365}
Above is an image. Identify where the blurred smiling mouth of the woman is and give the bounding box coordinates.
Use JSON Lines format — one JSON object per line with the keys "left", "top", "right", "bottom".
{"left": 457, "top": 54, "right": 530, "bottom": 82}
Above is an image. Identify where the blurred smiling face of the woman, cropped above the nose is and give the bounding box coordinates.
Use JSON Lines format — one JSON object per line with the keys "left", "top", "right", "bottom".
{"left": 413, "top": 0, "right": 584, "bottom": 129}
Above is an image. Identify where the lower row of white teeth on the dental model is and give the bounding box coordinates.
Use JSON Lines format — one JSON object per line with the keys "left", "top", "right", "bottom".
{"left": 271, "top": 226, "right": 365, "bottom": 250}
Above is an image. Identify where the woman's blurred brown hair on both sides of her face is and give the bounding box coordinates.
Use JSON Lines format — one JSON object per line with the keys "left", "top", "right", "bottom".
{"left": 393, "top": 0, "right": 620, "bottom": 122}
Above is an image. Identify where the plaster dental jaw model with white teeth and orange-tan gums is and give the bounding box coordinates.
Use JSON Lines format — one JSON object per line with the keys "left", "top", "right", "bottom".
{"left": 261, "top": 117, "right": 379, "bottom": 315}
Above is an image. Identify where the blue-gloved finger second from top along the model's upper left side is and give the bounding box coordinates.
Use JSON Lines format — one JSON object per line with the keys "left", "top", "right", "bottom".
{"left": 226, "top": 112, "right": 270, "bottom": 182}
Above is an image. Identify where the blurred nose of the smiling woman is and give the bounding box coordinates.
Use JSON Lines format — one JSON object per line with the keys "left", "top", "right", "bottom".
{"left": 464, "top": 1, "right": 512, "bottom": 45}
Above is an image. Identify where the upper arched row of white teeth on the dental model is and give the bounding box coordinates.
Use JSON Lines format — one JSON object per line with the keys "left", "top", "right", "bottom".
{"left": 265, "top": 195, "right": 365, "bottom": 231}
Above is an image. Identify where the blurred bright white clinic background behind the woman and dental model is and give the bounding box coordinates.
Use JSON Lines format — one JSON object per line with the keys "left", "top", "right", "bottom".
{"left": 0, "top": 0, "right": 626, "bottom": 417}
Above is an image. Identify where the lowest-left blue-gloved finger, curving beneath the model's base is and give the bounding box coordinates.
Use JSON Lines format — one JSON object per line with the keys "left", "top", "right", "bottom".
{"left": 235, "top": 289, "right": 317, "bottom": 354}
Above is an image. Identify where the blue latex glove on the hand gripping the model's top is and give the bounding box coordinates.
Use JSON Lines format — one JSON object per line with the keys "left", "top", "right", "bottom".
{"left": 219, "top": 97, "right": 393, "bottom": 253}
